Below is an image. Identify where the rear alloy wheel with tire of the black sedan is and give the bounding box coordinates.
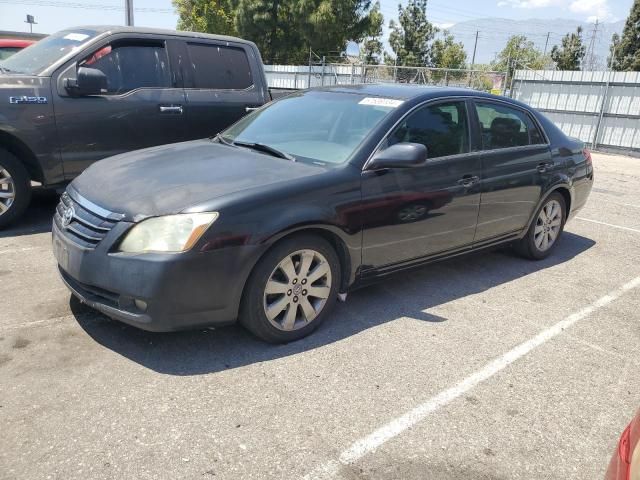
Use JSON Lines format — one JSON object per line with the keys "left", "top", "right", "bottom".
{"left": 515, "top": 192, "right": 567, "bottom": 260}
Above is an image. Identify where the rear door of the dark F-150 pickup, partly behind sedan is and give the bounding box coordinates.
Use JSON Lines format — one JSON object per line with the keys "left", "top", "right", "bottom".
{"left": 185, "top": 38, "right": 264, "bottom": 138}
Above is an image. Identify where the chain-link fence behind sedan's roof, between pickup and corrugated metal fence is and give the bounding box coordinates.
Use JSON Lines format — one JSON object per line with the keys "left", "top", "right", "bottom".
{"left": 265, "top": 63, "right": 507, "bottom": 94}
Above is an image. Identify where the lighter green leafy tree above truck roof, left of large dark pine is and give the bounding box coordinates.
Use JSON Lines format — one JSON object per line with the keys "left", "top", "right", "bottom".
{"left": 172, "top": 0, "right": 236, "bottom": 35}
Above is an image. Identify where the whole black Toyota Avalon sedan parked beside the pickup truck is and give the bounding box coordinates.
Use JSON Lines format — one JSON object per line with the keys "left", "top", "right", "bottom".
{"left": 53, "top": 85, "right": 593, "bottom": 342}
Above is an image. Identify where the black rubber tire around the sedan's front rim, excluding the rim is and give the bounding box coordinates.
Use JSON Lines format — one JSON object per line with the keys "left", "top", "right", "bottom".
{"left": 239, "top": 234, "right": 341, "bottom": 343}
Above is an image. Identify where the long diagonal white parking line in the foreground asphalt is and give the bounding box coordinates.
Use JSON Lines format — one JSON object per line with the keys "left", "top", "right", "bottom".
{"left": 304, "top": 277, "right": 640, "bottom": 480}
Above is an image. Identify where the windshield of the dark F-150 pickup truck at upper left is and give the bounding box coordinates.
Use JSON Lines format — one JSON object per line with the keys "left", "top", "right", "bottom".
{"left": 0, "top": 28, "right": 98, "bottom": 75}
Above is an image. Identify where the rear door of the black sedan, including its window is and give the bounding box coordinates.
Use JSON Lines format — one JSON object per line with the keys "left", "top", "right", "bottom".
{"left": 474, "top": 99, "right": 557, "bottom": 242}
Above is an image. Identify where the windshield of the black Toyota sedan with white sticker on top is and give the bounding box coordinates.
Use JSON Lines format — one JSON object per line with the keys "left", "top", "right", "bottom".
{"left": 222, "top": 91, "right": 402, "bottom": 164}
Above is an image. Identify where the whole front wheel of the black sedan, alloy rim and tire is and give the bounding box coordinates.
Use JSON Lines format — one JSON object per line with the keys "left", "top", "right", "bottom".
{"left": 239, "top": 235, "right": 340, "bottom": 343}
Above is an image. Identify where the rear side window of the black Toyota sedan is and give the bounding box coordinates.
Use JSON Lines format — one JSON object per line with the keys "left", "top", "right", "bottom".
{"left": 476, "top": 102, "right": 544, "bottom": 150}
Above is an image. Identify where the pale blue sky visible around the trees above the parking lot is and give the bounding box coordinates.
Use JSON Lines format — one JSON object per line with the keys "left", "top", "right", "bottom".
{"left": 0, "top": 0, "right": 633, "bottom": 33}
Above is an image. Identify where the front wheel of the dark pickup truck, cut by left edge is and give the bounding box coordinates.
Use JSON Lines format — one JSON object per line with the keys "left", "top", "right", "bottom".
{"left": 0, "top": 149, "right": 31, "bottom": 229}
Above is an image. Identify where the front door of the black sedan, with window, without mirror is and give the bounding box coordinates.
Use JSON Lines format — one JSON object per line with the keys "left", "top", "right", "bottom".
{"left": 361, "top": 100, "right": 481, "bottom": 268}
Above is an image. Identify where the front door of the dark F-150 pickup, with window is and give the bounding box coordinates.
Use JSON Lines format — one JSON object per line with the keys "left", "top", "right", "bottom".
{"left": 55, "top": 38, "right": 186, "bottom": 178}
